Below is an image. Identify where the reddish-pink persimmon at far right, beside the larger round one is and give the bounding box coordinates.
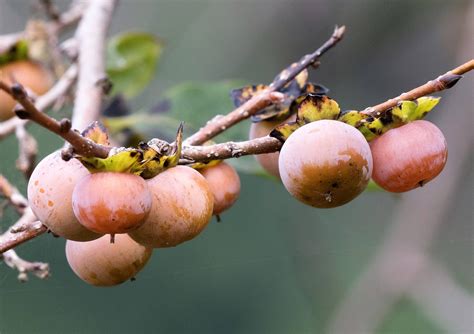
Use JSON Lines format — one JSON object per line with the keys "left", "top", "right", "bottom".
{"left": 370, "top": 120, "right": 448, "bottom": 193}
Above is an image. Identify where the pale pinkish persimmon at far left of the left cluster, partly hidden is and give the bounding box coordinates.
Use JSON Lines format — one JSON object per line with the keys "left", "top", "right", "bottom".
{"left": 28, "top": 152, "right": 101, "bottom": 241}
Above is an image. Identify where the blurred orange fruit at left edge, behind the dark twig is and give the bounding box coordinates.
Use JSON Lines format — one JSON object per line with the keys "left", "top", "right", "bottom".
{"left": 0, "top": 60, "right": 53, "bottom": 121}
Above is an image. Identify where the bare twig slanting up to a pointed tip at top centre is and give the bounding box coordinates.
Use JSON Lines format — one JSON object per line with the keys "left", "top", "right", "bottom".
{"left": 184, "top": 26, "right": 345, "bottom": 145}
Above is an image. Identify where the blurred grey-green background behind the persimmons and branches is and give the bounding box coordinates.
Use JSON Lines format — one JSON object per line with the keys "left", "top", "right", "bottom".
{"left": 0, "top": 0, "right": 474, "bottom": 334}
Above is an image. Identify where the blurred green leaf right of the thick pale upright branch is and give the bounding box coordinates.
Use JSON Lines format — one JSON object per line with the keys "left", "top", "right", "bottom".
{"left": 107, "top": 33, "right": 162, "bottom": 98}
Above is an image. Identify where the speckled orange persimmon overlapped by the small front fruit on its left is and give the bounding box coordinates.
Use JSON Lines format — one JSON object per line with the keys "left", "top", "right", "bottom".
{"left": 129, "top": 166, "right": 214, "bottom": 248}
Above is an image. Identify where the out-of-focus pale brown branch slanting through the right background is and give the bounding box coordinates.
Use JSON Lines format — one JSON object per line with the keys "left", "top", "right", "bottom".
{"left": 328, "top": 20, "right": 474, "bottom": 334}
